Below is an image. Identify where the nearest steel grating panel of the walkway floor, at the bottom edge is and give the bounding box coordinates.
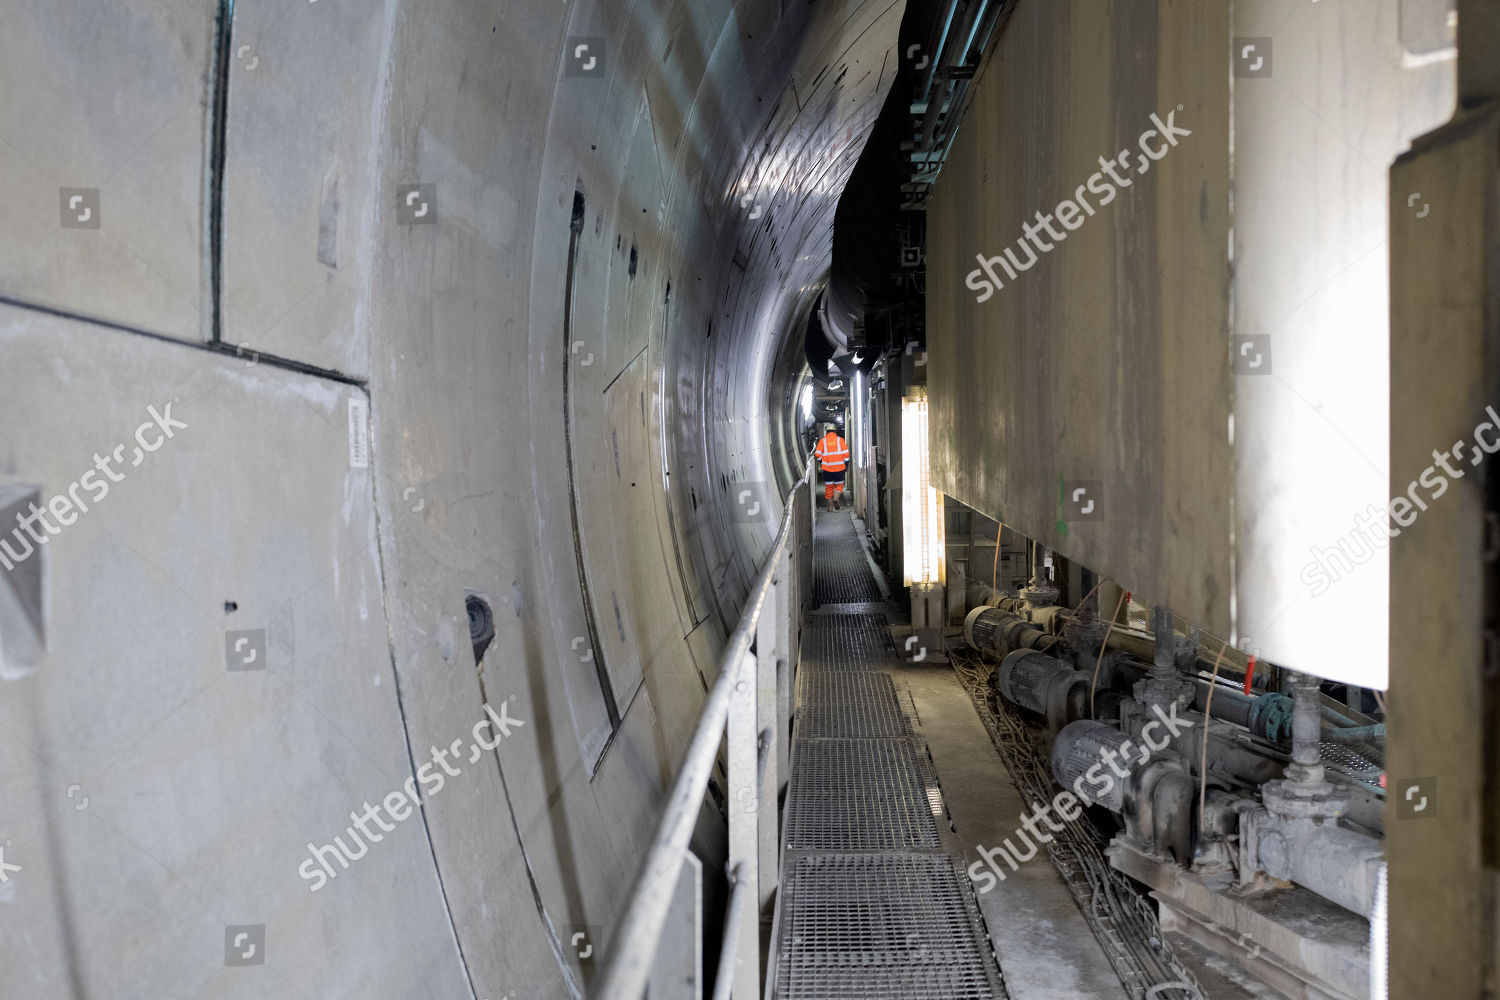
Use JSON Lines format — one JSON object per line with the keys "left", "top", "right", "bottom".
{"left": 776, "top": 853, "right": 1005, "bottom": 1000}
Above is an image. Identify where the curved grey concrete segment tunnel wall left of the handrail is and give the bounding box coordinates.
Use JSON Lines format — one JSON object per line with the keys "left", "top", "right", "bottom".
{"left": 0, "top": 0, "right": 902, "bottom": 997}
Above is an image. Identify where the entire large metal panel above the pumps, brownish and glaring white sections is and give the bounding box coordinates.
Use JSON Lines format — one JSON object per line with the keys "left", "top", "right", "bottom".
{"left": 927, "top": 0, "right": 1454, "bottom": 688}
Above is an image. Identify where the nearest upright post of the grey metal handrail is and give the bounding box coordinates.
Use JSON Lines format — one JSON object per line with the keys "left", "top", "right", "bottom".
{"left": 725, "top": 649, "right": 761, "bottom": 1000}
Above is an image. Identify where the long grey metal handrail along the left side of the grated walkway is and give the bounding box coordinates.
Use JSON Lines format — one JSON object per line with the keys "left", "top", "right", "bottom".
{"left": 593, "top": 459, "right": 815, "bottom": 1000}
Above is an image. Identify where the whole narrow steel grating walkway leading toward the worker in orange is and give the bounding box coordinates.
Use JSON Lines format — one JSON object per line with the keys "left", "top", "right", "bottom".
{"left": 773, "top": 513, "right": 1005, "bottom": 1000}
